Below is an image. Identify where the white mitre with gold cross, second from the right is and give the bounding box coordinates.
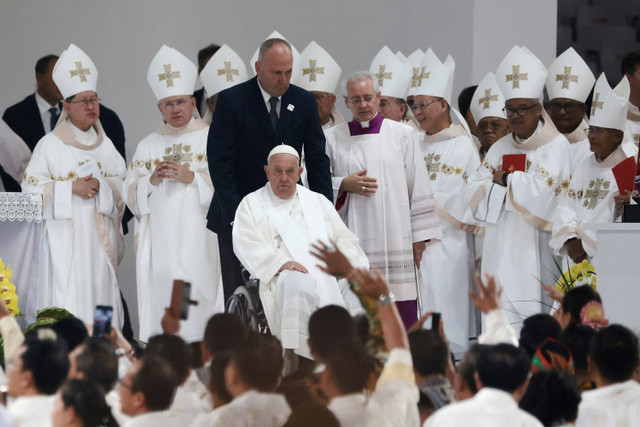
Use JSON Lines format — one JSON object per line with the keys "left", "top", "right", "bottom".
{"left": 546, "top": 47, "right": 596, "bottom": 103}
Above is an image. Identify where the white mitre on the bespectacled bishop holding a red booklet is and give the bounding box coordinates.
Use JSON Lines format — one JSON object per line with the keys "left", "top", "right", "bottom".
{"left": 496, "top": 46, "right": 547, "bottom": 100}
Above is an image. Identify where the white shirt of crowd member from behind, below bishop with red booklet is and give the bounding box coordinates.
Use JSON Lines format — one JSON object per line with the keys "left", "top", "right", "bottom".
{"left": 424, "top": 387, "right": 542, "bottom": 427}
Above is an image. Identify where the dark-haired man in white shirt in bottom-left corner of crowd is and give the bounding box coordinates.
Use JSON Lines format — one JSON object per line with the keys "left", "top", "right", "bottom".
{"left": 7, "top": 329, "right": 69, "bottom": 427}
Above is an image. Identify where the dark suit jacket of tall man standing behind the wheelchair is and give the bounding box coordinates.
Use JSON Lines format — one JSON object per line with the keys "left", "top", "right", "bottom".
{"left": 207, "top": 77, "right": 333, "bottom": 232}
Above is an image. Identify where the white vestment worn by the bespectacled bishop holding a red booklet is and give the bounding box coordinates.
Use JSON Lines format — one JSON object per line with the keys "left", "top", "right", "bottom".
{"left": 469, "top": 118, "right": 572, "bottom": 330}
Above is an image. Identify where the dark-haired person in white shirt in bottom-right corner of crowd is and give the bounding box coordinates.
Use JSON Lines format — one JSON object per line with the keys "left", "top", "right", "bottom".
{"left": 576, "top": 324, "right": 640, "bottom": 427}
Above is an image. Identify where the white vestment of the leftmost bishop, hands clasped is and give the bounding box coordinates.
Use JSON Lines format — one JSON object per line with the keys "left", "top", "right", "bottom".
{"left": 22, "top": 120, "right": 126, "bottom": 329}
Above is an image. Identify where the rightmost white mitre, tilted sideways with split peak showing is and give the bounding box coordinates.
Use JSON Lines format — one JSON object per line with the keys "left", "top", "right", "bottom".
{"left": 589, "top": 73, "right": 631, "bottom": 132}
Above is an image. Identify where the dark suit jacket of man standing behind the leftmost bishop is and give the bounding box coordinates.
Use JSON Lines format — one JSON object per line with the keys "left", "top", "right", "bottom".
{"left": 0, "top": 93, "right": 131, "bottom": 233}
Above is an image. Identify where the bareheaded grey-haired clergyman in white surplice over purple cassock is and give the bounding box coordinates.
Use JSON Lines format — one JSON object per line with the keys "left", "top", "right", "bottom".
{"left": 326, "top": 73, "right": 442, "bottom": 328}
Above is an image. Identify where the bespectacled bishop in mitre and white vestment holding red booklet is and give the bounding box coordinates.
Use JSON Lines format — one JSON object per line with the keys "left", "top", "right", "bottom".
{"left": 469, "top": 46, "right": 572, "bottom": 330}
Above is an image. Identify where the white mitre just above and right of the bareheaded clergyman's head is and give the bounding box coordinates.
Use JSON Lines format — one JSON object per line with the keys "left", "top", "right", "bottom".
{"left": 369, "top": 46, "right": 411, "bottom": 99}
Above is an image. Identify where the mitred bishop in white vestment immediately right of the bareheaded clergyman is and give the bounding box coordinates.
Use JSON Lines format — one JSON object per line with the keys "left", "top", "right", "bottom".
{"left": 413, "top": 49, "right": 484, "bottom": 351}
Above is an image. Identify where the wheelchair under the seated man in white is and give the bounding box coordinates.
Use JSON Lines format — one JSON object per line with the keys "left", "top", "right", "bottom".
{"left": 225, "top": 267, "right": 271, "bottom": 335}
